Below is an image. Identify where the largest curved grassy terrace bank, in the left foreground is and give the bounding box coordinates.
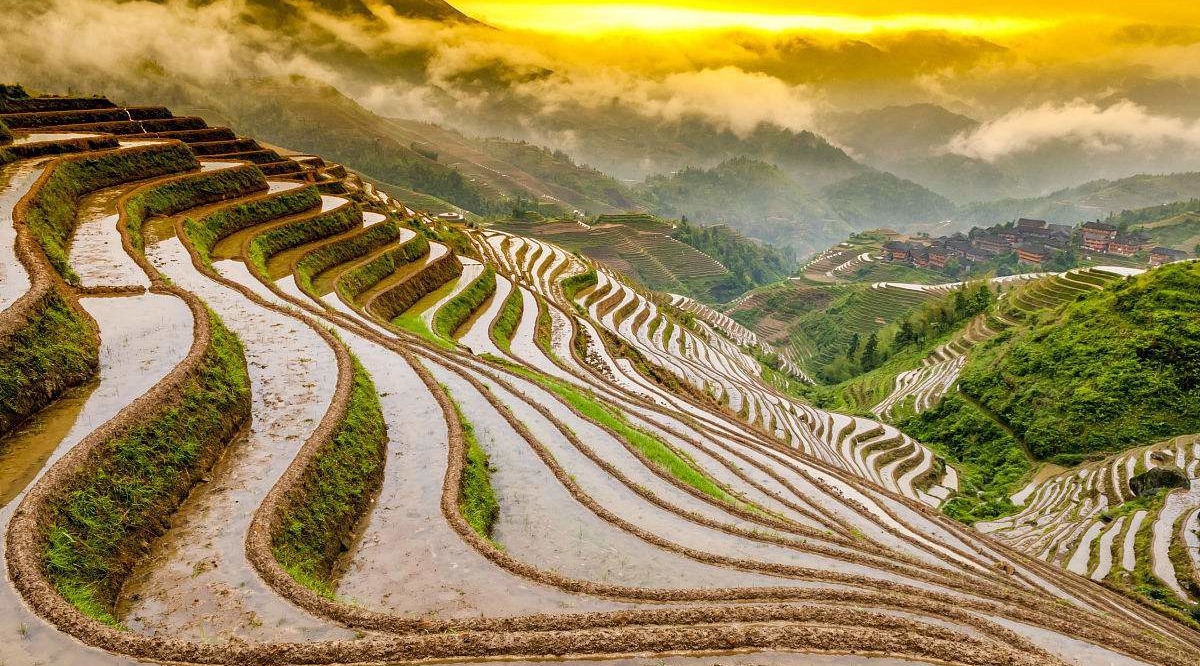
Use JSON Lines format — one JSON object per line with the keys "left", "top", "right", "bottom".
{"left": 46, "top": 312, "right": 250, "bottom": 625}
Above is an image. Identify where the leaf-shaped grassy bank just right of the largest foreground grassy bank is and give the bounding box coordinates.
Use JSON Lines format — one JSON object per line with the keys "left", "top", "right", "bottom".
{"left": 271, "top": 359, "right": 388, "bottom": 598}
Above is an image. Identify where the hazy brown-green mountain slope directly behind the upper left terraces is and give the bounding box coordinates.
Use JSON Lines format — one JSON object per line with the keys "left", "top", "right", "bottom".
{"left": 175, "top": 79, "right": 636, "bottom": 215}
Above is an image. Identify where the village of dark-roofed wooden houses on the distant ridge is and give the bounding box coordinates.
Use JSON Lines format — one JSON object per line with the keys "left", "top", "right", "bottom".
{"left": 883, "top": 217, "right": 1188, "bottom": 270}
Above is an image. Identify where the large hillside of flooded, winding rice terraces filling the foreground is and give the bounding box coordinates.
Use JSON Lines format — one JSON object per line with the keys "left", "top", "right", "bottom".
{"left": 0, "top": 88, "right": 1200, "bottom": 666}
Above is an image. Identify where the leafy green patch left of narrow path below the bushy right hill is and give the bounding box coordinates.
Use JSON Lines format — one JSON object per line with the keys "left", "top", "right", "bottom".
{"left": 899, "top": 394, "right": 1031, "bottom": 524}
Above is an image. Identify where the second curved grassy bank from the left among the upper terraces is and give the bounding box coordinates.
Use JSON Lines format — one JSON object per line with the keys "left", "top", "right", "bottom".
{"left": 125, "top": 166, "right": 266, "bottom": 250}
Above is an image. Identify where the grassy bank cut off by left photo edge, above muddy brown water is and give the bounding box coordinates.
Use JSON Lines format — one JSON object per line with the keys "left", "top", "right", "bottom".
{"left": 0, "top": 294, "right": 100, "bottom": 436}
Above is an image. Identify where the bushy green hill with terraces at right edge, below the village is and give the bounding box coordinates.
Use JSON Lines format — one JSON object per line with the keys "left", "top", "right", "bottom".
{"left": 820, "top": 258, "right": 1200, "bottom": 622}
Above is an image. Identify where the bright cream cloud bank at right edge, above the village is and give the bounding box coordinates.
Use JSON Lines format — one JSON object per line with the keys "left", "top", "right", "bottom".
{"left": 947, "top": 100, "right": 1200, "bottom": 162}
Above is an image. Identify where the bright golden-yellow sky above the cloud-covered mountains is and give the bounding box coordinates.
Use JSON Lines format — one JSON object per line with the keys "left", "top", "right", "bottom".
{"left": 454, "top": 0, "right": 1200, "bottom": 35}
